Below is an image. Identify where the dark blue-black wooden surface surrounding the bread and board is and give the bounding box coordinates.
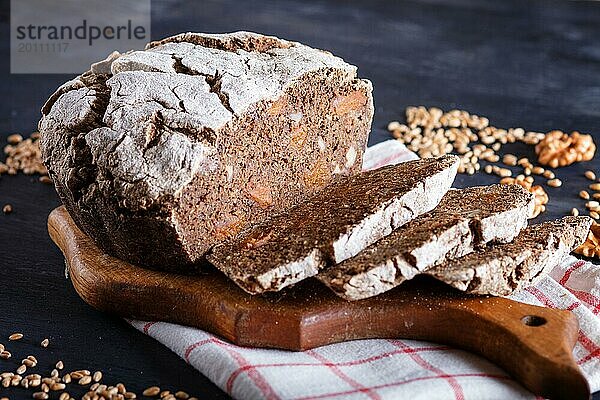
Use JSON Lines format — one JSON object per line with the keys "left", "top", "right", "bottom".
{"left": 0, "top": 0, "right": 600, "bottom": 399}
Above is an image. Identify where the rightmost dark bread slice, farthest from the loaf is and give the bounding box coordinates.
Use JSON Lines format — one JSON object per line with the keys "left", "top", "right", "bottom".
{"left": 427, "top": 217, "right": 592, "bottom": 296}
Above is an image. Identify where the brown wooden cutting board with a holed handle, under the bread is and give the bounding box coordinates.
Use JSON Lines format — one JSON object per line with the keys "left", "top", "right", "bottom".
{"left": 48, "top": 207, "right": 590, "bottom": 400}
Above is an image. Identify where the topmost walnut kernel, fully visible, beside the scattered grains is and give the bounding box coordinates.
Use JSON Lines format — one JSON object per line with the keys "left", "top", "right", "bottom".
{"left": 535, "top": 131, "right": 596, "bottom": 168}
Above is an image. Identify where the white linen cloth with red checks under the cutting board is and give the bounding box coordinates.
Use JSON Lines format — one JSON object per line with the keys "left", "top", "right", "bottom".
{"left": 130, "top": 141, "right": 600, "bottom": 400}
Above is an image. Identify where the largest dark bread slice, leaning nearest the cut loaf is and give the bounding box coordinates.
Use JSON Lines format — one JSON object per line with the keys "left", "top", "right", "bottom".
{"left": 207, "top": 156, "right": 458, "bottom": 294}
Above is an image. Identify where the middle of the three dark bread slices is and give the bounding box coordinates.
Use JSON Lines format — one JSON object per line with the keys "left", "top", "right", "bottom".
{"left": 317, "top": 185, "right": 534, "bottom": 300}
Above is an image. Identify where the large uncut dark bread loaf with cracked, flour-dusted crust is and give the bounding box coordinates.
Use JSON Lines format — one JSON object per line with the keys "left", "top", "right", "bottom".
{"left": 39, "top": 32, "right": 373, "bottom": 269}
